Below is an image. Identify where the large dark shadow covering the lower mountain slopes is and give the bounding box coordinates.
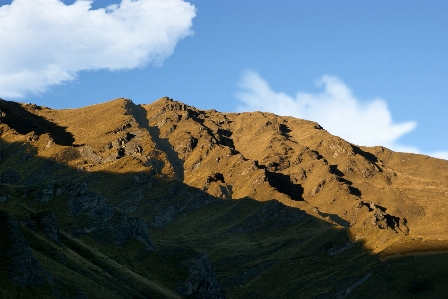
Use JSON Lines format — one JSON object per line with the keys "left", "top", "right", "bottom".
{"left": 0, "top": 140, "right": 448, "bottom": 298}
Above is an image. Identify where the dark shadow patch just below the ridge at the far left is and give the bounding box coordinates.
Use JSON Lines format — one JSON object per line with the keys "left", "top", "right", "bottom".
{"left": 0, "top": 99, "right": 75, "bottom": 146}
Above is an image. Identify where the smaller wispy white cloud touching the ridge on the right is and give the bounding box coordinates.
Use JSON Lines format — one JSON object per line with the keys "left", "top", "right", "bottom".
{"left": 236, "top": 71, "right": 448, "bottom": 159}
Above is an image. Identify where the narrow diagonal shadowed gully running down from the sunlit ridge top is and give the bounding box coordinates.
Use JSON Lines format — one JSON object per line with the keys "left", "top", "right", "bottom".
{"left": 127, "top": 102, "right": 184, "bottom": 181}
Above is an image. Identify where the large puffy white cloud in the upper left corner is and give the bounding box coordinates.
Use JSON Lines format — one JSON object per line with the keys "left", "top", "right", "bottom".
{"left": 0, "top": 0, "right": 196, "bottom": 98}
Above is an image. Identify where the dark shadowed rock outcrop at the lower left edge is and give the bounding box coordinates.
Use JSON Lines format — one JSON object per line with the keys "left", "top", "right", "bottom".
{"left": 0, "top": 211, "right": 52, "bottom": 288}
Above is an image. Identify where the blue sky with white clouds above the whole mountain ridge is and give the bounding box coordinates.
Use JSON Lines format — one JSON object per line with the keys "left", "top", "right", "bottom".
{"left": 0, "top": 0, "right": 448, "bottom": 159}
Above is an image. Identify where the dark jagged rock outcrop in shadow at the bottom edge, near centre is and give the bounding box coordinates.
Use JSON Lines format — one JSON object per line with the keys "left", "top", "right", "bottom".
{"left": 176, "top": 253, "right": 225, "bottom": 299}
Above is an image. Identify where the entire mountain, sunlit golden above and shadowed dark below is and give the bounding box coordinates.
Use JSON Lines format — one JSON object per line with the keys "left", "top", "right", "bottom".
{"left": 0, "top": 97, "right": 448, "bottom": 298}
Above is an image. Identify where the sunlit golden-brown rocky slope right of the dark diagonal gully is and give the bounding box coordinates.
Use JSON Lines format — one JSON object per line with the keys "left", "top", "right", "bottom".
{"left": 135, "top": 98, "right": 448, "bottom": 252}
